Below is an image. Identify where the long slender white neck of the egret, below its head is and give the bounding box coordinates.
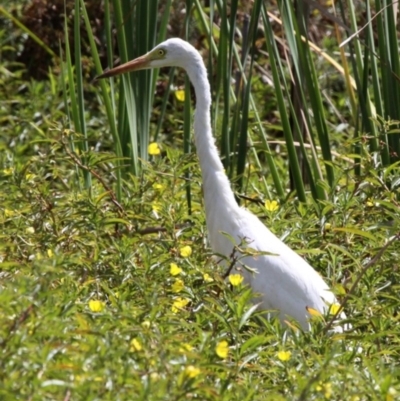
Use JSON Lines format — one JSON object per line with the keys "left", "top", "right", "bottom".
{"left": 185, "top": 53, "right": 239, "bottom": 216}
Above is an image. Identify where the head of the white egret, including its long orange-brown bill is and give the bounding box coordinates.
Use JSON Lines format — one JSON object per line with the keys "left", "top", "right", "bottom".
{"left": 96, "top": 38, "right": 201, "bottom": 79}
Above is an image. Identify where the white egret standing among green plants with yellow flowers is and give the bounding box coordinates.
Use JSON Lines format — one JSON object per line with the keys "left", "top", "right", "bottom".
{"left": 97, "top": 38, "right": 343, "bottom": 330}
